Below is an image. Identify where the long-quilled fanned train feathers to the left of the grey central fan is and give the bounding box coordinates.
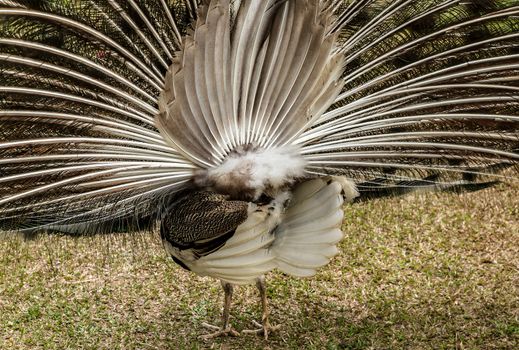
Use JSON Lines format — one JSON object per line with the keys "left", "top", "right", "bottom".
{"left": 0, "top": 0, "right": 196, "bottom": 233}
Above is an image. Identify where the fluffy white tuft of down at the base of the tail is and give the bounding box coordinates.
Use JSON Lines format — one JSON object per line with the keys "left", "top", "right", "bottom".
{"left": 206, "top": 147, "right": 306, "bottom": 199}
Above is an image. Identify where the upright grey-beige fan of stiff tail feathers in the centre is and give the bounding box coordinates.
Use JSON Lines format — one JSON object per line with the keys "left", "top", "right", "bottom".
{"left": 157, "top": 0, "right": 343, "bottom": 167}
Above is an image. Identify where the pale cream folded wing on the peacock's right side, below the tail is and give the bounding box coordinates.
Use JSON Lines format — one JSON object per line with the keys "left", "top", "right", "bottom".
{"left": 270, "top": 177, "right": 358, "bottom": 277}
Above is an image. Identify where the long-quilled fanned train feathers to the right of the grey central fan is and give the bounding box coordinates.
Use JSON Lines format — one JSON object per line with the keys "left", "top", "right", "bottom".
{"left": 302, "top": 0, "right": 519, "bottom": 192}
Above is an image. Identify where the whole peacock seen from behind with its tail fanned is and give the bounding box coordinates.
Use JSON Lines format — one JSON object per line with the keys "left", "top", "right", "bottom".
{"left": 0, "top": 0, "right": 519, "bottom": 338}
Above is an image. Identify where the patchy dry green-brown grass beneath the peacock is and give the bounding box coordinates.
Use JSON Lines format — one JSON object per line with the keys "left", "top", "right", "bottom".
{"left": 0, "top": 185, "right": 519, "bottom": 349}
